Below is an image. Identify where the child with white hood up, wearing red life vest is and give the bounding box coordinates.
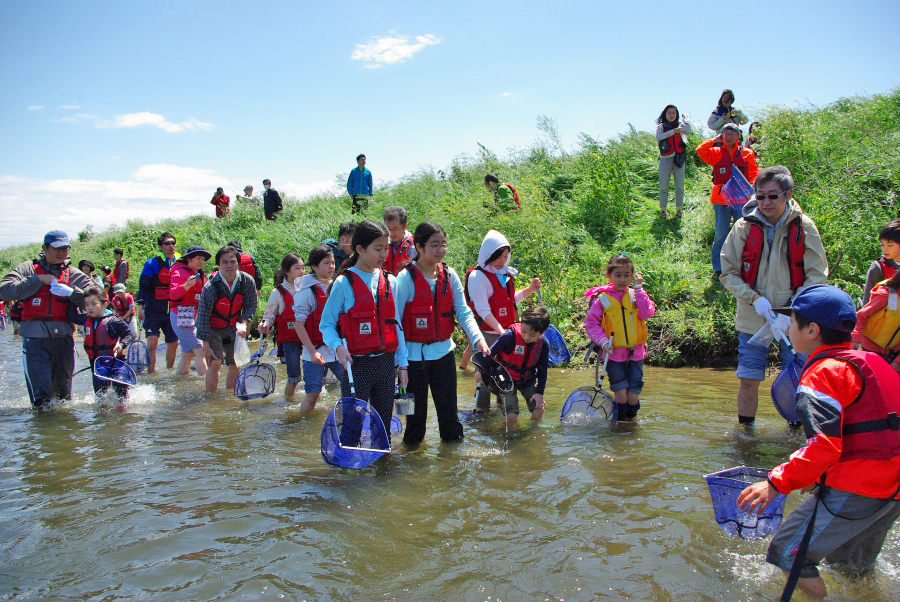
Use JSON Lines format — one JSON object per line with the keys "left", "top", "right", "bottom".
{"left": 463, "top": 230, "right": 541, "bottom": 398}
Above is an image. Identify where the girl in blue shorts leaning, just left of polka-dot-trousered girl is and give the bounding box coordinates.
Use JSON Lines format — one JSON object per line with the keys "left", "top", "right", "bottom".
{"left": 294, "top": 245, "right": 344, "bottom": 412}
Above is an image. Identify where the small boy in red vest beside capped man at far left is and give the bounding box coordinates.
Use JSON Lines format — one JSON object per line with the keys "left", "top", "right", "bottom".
{"left": 69, "top": 287, "right": 134, "bottom": 397}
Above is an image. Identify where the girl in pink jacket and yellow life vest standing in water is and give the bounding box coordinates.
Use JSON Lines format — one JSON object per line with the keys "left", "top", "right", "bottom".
{"left": 584, "top": 253, "right": 656, "bottom": 419}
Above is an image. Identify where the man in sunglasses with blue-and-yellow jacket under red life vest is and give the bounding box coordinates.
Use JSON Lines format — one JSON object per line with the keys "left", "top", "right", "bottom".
{"left": 135, "top": 232, "right": 179, "bottom": 372}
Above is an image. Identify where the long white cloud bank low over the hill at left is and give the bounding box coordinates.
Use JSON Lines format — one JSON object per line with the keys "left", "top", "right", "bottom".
{"left": 0, "top": 163, "right": 338, "bottom": 247}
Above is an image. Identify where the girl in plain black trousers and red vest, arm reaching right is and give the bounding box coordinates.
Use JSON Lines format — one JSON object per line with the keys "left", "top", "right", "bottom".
{"left": 397, "top": 222, "right": 490, "bottom": 445}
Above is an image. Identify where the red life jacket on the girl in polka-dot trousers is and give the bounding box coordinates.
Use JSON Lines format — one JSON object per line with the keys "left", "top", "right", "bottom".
{"left": 338, "top": 270, "right": 399, "bottom": 355}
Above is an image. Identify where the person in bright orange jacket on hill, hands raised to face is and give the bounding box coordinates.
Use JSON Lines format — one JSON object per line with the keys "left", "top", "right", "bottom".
{"left": 697, "top": 123, "right": 759, "bottom": 278}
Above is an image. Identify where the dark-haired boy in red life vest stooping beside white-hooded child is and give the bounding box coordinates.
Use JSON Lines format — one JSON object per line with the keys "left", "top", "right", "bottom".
{"left": 486, "top": 307, "right": 550, "bottom": 422}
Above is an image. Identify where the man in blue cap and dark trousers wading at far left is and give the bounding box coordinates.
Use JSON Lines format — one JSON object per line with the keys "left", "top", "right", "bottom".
{"left": 0, "top": 230, "right": 92, "bottom": 410}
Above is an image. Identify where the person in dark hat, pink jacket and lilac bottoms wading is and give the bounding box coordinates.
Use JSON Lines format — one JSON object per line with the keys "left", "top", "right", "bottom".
{"left": 169, "top": 245, "right": 212, "bottom": 376}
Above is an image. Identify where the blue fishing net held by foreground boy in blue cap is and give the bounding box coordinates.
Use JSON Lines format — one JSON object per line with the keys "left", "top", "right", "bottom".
{"left": 704, "top": 466, "right": 787, "bottom": 539}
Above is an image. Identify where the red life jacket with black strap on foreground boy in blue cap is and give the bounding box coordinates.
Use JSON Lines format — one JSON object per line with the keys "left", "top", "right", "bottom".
{"left": 803, "top": 349, "right": 900, "bottom": 460}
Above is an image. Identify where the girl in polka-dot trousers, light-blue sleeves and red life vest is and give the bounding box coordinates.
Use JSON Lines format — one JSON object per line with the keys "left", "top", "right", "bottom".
{"left": 319, "top": 220, "right": 408, "bottom": 436}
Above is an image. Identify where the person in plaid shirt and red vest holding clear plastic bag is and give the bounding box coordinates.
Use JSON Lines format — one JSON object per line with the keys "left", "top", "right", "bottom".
{"left": 196, "top": 247, "right": 257, "bottom": 393}
